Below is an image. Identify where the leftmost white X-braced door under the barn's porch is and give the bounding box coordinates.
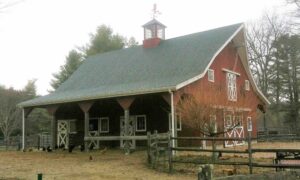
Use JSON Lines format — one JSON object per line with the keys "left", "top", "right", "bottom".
{"left": 57, "top": 120, "right": 69, "bottom": 148}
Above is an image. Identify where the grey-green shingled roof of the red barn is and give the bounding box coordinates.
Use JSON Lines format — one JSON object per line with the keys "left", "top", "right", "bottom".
{"left": 20, "top": 23, "right": 268, "bottom": 107}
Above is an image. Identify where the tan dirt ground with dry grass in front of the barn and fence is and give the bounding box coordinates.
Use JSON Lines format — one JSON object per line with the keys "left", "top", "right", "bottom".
{"left": 0, "top": 142, "right": 300, "bottom": 180}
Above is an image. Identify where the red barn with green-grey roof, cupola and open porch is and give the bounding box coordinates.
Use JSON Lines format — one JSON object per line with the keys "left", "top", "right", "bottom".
{"left": 20, "top": 19, "right": 269, "bottom": 151}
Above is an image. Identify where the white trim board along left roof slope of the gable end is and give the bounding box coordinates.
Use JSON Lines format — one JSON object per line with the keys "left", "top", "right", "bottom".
{"left": 176, "top": 24, "right": 244, "bottom": 90}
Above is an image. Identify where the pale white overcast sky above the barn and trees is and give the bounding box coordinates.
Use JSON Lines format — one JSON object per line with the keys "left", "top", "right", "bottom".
{"left": 0, "top": 0, "right": 285, "bottom": 95}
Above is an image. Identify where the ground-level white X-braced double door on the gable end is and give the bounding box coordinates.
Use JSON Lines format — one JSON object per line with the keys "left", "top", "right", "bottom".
{"left": 224, "top": 113, "right": 244, "bottom": 147}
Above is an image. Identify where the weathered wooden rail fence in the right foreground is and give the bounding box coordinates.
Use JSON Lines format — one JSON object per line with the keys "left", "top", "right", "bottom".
{"left": 148, "top": 132, "right": 300, "bottom": 174}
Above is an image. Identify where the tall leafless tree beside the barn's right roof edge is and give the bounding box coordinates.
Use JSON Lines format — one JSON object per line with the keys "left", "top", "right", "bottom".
{"left": 247, "top": 13, "right": 290, "bottom": 98}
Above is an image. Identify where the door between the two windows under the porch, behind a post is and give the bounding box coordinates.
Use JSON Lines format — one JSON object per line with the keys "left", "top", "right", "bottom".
{"left": 120, "top": 116, "right": 135, "bottom": 149}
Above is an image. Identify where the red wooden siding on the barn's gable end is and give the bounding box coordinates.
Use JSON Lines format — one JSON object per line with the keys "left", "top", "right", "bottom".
{"left": 175, "top": 43, "right": 263, "bottom": 136}
